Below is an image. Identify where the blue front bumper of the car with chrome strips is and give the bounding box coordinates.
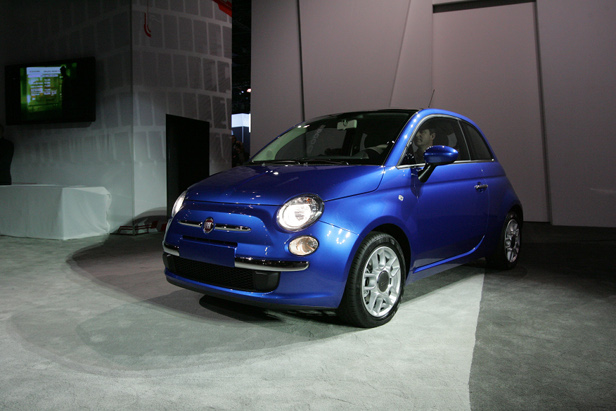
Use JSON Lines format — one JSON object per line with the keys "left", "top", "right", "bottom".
{"left": 163, "top": 205, "right": 357, "bottom": 309}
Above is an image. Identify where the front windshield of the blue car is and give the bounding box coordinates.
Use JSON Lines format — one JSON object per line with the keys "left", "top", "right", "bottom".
{"left": 251, "top": 111, "right": 413, "bottom": 165}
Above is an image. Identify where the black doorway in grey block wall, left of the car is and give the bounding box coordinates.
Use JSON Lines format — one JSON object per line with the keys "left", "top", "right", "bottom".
{"left": 166, "top": 114, "right": 210, "bottom": 216}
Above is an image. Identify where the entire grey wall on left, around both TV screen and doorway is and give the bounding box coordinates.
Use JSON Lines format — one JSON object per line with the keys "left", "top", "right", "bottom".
{"left": 0, "top": 0, "right": 231, "bottom": 230}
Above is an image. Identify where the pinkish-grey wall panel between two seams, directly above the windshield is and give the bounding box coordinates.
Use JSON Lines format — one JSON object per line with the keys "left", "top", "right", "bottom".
{"left": 300, "top": 0, "right": 410, "bottom": 118}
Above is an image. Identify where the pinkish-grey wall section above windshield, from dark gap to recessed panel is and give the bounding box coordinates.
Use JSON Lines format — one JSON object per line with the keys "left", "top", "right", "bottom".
{"left": 251, "top": 0, "right": 432, "bottom": 154}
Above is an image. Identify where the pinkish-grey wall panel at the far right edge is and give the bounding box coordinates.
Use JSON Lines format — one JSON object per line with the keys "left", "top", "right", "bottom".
{"left": 537, "top": 0, "right": 616, "bottom": 227}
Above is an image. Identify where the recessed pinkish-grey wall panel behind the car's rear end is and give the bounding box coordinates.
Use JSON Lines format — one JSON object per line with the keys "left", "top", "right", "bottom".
{"left": 432, "top": 3, "right": 549, "bottom": 221}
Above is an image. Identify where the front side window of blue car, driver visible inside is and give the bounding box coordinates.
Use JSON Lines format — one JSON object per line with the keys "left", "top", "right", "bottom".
{"left": 401, "top": 117, "right": 470, "bottom": 165}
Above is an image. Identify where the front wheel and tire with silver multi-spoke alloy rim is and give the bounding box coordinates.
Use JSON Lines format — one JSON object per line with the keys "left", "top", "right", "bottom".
{"left": 338, "top": 232, "right": 406, "bottom": 328}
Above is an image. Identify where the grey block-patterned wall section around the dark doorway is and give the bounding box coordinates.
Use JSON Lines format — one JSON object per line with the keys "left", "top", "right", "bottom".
{"left": 132, "top": 0, "right": 231, "bottom": 216}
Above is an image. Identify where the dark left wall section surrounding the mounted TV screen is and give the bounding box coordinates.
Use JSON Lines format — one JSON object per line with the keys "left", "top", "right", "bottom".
{"left": 0, "top": 0, "right": 134, "bottom": 227}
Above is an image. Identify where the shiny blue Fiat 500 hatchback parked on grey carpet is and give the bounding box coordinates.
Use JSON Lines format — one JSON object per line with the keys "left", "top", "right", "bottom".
{"left": 163, "top": 109, "right": 523, "bottom": 327}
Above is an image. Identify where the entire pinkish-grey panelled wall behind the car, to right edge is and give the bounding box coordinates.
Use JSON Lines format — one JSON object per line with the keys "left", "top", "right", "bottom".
{"left": 252, "top": 0, "right": 616, "bottom": 227}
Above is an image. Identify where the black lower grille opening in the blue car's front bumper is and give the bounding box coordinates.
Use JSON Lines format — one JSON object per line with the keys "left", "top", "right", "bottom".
{"left": 165, "top": 254, "right": 280, "bottom": 292}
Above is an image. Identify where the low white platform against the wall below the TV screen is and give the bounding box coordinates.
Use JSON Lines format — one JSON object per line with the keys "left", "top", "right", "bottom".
{"left": 0, "top": 184, "right": 111, "bottom": 240}
